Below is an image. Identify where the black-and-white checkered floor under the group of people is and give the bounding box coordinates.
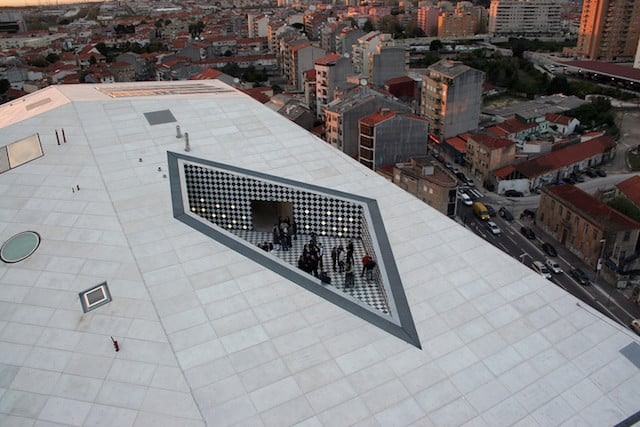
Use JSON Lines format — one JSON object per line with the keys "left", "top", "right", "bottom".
{"left": 234, "top": 230, "right": 389, "bottom": 313}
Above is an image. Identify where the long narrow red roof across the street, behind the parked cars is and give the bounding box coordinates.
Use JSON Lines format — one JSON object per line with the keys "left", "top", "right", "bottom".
{"left": 516, "top": 136, "right": 616, "bottom": 178}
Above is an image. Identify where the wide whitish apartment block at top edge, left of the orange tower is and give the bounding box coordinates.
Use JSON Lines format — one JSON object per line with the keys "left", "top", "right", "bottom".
{"left": 488, "top": 0, "right": 561, "bottom": 36}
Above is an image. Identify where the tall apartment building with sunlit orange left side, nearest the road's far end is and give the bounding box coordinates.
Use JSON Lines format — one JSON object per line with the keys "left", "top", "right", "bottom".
{"left": 421, "top": 59, "right": 484, "bottom": 141}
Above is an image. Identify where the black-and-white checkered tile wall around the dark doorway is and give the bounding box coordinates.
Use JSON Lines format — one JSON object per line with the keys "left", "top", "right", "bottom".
{"left": 184, "top": 163, "right": 371, "bottom": 239}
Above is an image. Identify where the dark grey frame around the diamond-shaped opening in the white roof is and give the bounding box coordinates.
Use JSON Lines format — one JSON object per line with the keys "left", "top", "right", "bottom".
{"left": 167, "top": 151, "right": 422, "bottom": 349}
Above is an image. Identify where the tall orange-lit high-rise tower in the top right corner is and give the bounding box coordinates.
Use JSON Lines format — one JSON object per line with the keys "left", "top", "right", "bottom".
{"left": 575, "top": 0, "right": 640, "bottom": 61}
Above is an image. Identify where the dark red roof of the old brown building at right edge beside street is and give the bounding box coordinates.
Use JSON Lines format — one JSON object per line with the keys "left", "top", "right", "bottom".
{"left": 542, "top": 184, "right": 640, "bottom": 230}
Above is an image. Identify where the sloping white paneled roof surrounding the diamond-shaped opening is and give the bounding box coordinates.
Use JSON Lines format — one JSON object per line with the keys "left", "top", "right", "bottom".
{"left": 0, "top": 81, "right": 640, "bottom": 427}
